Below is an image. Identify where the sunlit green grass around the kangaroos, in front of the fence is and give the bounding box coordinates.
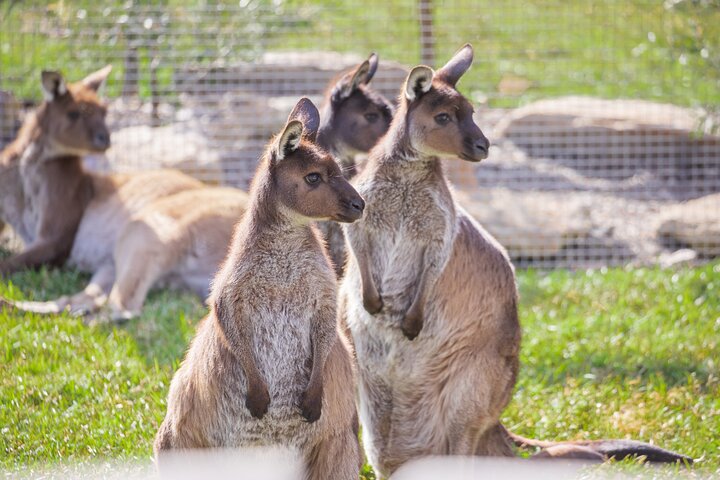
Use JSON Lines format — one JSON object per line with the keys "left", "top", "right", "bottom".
{"left": 0, "top": 262, "right": 720, "bottom": 478}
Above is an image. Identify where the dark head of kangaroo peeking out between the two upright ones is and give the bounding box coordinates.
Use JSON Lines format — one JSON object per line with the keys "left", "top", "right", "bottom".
{"left": 319, "top": 53, "right": 393, "bottom": 161}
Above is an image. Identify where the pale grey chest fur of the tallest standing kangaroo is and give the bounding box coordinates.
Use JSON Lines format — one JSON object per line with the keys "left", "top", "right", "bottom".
{"left": 346, "top": 163, "right": 455, "bottom": 326}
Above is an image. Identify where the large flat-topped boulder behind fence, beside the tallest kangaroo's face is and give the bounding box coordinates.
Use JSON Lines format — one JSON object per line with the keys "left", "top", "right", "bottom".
{"left": 494, "top": 97, "right": 720, "bottom": 198}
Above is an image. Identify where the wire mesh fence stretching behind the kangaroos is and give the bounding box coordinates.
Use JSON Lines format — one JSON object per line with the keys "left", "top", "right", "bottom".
{"left": 0, "top": 0, "right": 720, "bottom": 267}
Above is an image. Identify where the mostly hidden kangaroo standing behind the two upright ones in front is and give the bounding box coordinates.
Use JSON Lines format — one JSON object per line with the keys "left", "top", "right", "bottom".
{"left": 317, "top": 53, "right": 394, "bottom": 278}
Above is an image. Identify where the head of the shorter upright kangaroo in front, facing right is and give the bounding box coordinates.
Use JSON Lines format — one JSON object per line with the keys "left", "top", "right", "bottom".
{"left": 269, "top": 98, "right": 365, "bottom": 222}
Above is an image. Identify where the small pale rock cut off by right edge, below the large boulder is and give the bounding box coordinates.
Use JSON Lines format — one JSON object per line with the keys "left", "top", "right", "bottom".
{"left": 658, "top": 193, "right": 720, "bottom": 257}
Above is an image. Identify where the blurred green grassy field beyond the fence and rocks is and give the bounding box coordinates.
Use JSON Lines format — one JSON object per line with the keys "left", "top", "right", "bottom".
{"left": 0, "top": 0, "right": 720, "bottom": 108}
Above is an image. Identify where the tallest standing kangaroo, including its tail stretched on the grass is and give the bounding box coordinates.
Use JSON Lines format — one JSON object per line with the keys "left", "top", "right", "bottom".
{"left": 339, "top": 45, "right": 687, "bottom": 477}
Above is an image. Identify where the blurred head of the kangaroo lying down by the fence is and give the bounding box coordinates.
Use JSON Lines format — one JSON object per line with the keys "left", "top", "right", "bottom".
{"left": 36, "top": 65, "right": 112, "bottom": 155}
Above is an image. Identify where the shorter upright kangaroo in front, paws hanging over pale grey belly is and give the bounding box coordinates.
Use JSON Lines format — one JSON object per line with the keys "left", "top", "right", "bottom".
{"left": 154, "top": 98, "right": 364, "bottom": 479}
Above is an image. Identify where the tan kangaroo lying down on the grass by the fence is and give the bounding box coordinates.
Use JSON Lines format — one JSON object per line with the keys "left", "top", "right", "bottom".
{"left": 0, "top": 66, "right": 247, "bottom": 319}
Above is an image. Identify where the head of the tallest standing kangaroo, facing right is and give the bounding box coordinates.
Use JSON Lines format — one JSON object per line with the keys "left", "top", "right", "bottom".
{"left": 398, "top": 44, "right": 490, "bottom": 162}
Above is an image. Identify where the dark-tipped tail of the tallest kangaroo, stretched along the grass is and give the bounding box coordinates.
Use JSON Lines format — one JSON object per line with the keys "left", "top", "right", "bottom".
{"left": 506, "top": 429, "right": 693, "bottom": 465}
